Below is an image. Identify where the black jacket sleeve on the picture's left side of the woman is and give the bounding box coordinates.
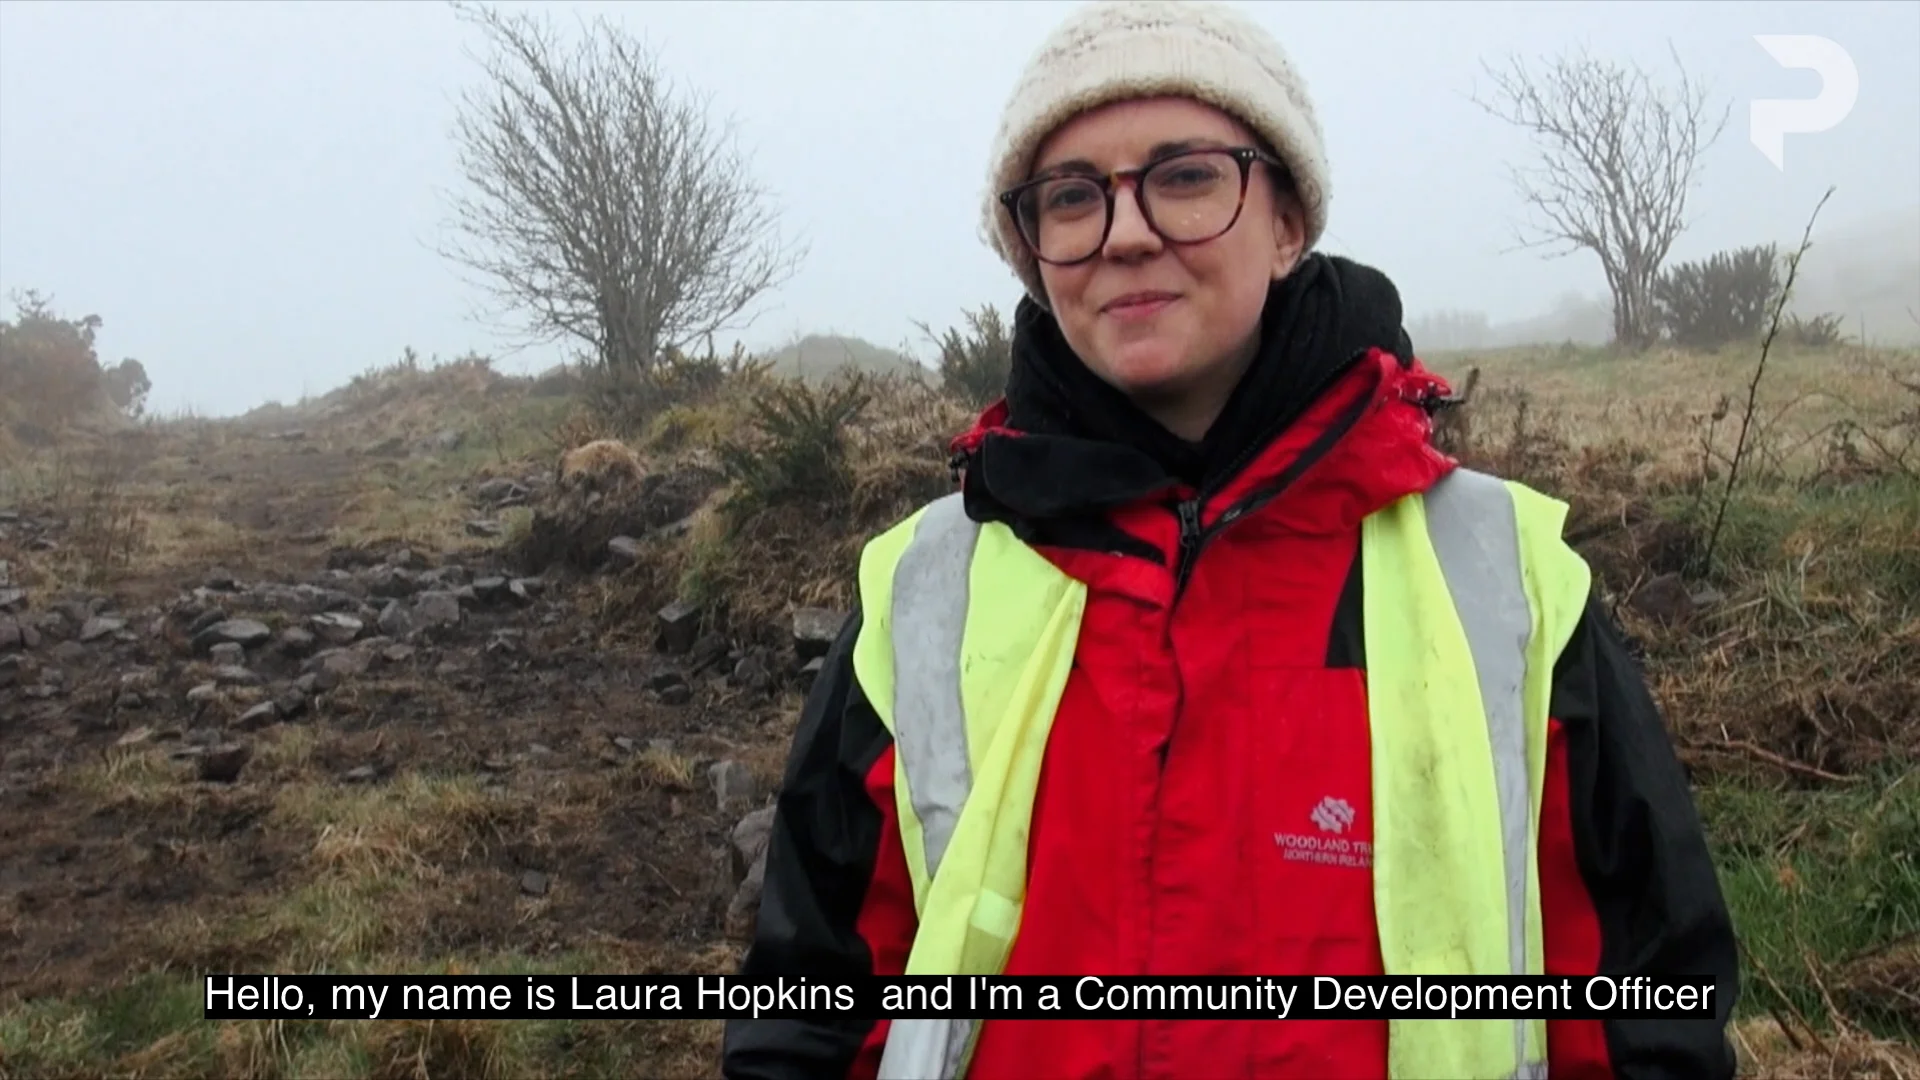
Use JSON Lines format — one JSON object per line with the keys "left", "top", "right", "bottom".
{"left": 720, "top": 611, "right": 889, "bottom": 1080}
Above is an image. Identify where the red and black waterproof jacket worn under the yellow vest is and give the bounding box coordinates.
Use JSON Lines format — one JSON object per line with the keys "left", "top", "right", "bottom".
{"left": 724, "top": 255, "right": 1736, "bottom": 1080}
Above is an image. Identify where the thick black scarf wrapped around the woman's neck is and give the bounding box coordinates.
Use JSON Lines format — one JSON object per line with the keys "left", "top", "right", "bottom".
{"left": 1006, "top": 254, "right": 1411, "bottom": 494}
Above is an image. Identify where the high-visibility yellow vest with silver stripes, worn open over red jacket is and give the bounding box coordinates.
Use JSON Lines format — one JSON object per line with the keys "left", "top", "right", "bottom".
{"left": 854, "top": 469, "right": 1592, "bottom": 1080}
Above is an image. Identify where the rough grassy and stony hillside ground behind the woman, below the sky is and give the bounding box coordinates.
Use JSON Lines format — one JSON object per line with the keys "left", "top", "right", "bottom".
{"left": 0, "top": 336, "right": 1920, "bottom": 1080}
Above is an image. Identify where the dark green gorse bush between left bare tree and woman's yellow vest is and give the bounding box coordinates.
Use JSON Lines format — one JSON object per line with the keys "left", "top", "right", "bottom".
{"left": 716, "top": 373, "right": 874, "bottom": 515}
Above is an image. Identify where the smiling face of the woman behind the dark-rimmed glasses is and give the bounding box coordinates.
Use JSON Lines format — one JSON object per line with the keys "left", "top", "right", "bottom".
{"left": 1033, "top": 98, "right": 1306, "bottom": 438}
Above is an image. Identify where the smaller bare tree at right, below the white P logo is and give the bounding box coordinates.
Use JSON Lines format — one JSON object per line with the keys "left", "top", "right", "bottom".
{"left": 1475, "top": 54, "right": 1728, "bottom": 348}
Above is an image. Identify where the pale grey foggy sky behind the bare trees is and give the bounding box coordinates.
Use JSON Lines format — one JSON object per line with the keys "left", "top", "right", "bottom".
{"left": 0, "top": 0, "right": 1920, "bottom": 415}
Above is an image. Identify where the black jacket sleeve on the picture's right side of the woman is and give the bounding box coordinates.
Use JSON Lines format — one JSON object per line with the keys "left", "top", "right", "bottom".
{"left": 1553, "top": 601, "right": 1740, "bottom": 1080}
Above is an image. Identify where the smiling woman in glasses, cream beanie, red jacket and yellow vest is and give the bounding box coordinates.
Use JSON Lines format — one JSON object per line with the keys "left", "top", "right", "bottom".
{"left": 724, "top": 2, "right": 1736, "bottom": 1078}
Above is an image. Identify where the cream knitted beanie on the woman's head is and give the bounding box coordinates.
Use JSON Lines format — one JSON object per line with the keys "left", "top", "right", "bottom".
{"left": 981, "top": 0, "right": 1329, "bottom": 307}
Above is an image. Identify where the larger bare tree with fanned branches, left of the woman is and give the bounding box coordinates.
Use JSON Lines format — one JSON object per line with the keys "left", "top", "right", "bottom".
{"left": 444, "top": 2, "right": 804, "bottom": 373}
